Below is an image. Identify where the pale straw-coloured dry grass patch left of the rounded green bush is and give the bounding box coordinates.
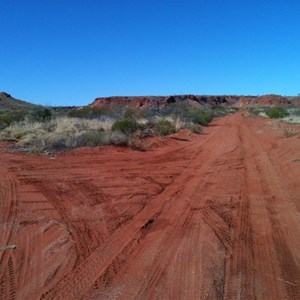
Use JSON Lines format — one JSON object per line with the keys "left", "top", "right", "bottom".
{"left": 0, "top": 117, "right": 122, "bottom": 152}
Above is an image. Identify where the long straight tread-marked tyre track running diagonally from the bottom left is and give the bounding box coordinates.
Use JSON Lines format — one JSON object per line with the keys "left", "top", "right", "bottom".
{"left": 42, "top": 123, "right": 225, "bottom": 299}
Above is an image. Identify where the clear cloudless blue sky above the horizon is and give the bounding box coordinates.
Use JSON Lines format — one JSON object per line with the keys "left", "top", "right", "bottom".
{"left": 0, "top": 0, "right": 300, "bottom": 105}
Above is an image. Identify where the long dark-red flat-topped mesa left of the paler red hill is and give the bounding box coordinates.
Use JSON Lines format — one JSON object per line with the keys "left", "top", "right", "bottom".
{"left": 90, "top": 95, "right": 244, "bottom": 108}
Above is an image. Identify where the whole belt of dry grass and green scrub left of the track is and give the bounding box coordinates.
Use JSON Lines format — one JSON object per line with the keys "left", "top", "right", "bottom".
{"left": 0, "top": 104, "right": 217, "bottom": 153}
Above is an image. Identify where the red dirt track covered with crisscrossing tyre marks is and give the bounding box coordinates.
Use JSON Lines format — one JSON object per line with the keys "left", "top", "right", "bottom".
{"left": 0, "top": 114, "right": 300, "bottom": 300}
